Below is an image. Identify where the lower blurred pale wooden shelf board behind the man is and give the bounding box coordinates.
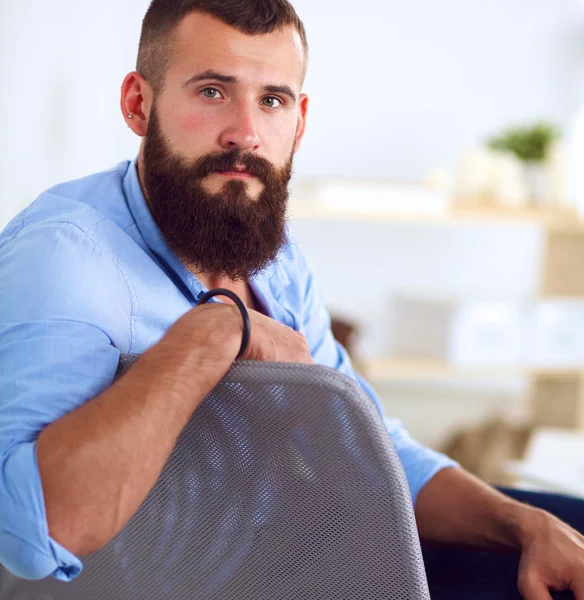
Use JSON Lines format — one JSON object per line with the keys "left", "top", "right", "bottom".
{"left": 360, "top": 358, "right": 584, "bottom": 381}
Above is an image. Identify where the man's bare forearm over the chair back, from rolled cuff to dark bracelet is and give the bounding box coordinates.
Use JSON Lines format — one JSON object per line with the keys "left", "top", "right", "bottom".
{"left": 37, "top": 305, "right": 241, "bottom": 555}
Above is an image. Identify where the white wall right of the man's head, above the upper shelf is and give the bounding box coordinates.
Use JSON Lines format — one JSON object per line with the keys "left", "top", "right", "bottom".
{"left": 296, "top": 0, "right": 584, "bottom": 179}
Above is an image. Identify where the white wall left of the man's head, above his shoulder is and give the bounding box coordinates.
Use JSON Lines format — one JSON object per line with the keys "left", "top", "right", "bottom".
{"left": 0, "top": 0, "right": 148, "bottom": 228}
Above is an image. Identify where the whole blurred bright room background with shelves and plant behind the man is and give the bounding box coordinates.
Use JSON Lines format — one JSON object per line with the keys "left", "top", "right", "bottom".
{"left": 0, "top": 0, "right": 584, "bottom": 496}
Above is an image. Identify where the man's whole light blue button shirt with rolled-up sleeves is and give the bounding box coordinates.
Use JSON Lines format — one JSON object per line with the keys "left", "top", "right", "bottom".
{"left": 0, "top": 161, "right": 456, "bottom": 581}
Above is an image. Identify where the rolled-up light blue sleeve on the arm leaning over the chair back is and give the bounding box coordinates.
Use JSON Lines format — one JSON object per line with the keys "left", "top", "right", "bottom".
{"left": 0, "top": 218, "right": 130, "bottom": 581}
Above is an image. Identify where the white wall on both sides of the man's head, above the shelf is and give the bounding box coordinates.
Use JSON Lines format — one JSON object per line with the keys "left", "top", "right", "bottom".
{"left": 0, "top": 0, "right": 584, "bottom": 227}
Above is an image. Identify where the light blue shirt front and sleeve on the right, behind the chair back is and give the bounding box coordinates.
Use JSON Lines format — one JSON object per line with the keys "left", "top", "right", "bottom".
{"left": 291, "top": 244, "right": 459, "bottom": 503}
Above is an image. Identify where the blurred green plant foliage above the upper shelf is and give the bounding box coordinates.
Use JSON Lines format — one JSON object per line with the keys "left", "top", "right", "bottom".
{"left": 487, "top": 122, "right": 560, "bottom": 162}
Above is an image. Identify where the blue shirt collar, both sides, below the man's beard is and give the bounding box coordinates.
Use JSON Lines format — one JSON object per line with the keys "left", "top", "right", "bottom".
{"left": 123, "top": 157, "right": 289, "bottom": 303}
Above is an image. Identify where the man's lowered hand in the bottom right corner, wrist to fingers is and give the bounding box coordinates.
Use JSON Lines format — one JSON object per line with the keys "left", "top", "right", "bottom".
{"left": 518, "top": 507, "right": 584, "bottom": 600}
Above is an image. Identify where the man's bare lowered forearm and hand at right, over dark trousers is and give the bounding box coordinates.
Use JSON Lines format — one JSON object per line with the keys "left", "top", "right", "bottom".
{"left": 415, "top": 468, "right": 584, "bottom": 600}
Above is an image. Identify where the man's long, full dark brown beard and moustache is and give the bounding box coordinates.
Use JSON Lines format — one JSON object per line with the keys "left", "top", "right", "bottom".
{"left": 143, "top": 107, "right": 294, "bottom": 280}
